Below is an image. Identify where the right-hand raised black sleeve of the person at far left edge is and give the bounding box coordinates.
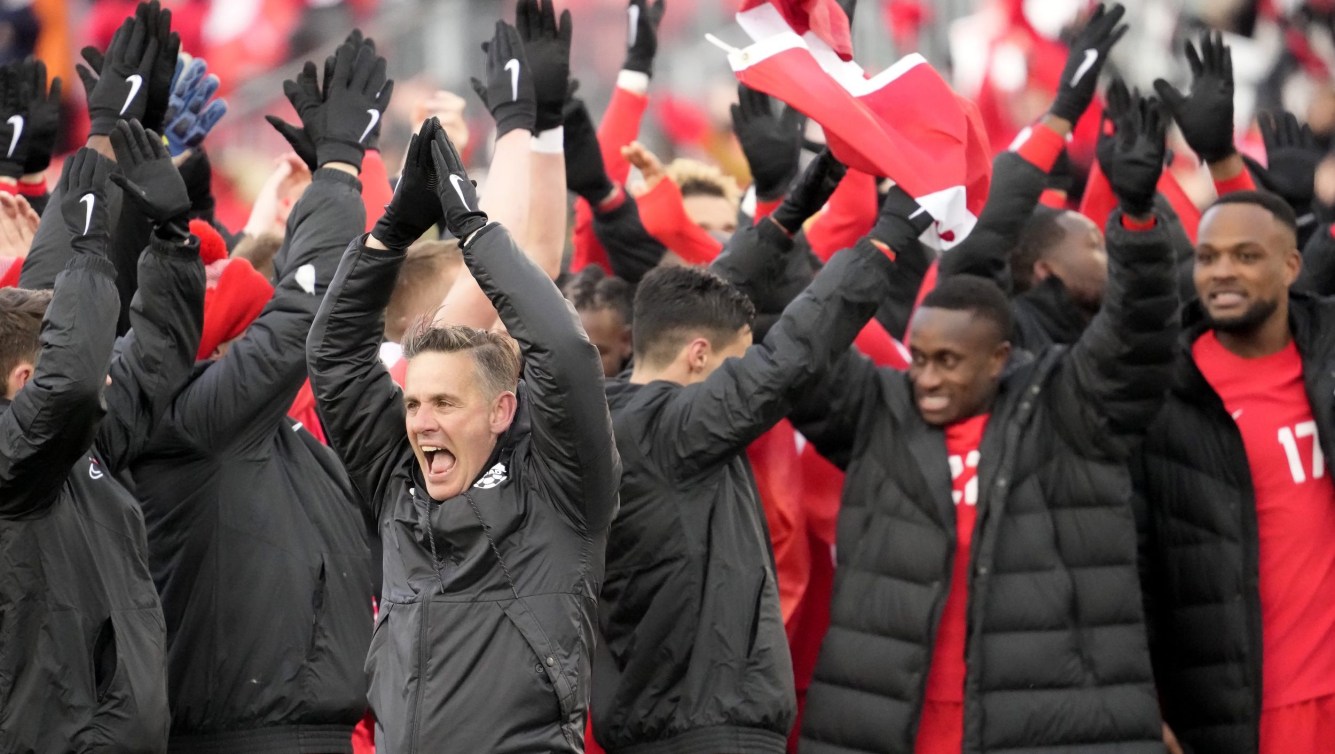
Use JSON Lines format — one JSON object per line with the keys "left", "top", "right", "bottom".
{"left": 97, "top": 235, "right": 204, "bottom": 472}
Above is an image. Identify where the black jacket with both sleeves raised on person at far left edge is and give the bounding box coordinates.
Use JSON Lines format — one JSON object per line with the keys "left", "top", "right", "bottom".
{"left": 0, "top": 232, "right": 204, "bottom": 754}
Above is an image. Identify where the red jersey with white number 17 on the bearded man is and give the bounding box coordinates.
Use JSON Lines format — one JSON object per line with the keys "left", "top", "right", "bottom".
{"left": 1192, "top": 331, "right": 1335, "bottom": 709}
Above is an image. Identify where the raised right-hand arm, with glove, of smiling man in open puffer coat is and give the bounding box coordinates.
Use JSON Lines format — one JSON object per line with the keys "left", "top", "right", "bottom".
{"left": 1049, "top": 94, "right": 1180, "bottom": 459}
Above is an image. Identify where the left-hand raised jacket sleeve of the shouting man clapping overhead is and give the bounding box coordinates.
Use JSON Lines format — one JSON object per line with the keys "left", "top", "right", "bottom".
{"left": 306, "top": 236, "right": 413, "bottom": 519}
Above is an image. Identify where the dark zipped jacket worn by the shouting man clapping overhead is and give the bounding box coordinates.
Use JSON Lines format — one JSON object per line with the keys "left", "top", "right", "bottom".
{"left": 307, "top": 224, "right": 621, "bottom": 754}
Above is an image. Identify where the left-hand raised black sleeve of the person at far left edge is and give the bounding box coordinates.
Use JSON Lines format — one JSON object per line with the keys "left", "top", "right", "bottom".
{"left": 0, "top": 252, "right": 119, "bottom": 519}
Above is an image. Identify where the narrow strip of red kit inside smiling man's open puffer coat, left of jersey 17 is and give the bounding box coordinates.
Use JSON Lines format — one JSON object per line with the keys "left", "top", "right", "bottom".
{"left": 914, "top": 414, "right": 989, "bottom": 754}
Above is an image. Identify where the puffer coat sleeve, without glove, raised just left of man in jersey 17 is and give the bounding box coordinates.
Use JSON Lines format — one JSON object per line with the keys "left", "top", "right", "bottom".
{"left": 1049, "top": 211, "right": 1181, "bottom": 460}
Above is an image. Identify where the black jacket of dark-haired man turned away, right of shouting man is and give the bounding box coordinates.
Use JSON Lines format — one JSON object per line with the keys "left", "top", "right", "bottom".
{"left": 594, "top": 242, "right": 928, "bottom": 754}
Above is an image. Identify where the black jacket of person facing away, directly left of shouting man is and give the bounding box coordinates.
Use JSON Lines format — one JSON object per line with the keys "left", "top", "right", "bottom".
{"left": 132, "top": 168, "right": 374, "bottom": 754}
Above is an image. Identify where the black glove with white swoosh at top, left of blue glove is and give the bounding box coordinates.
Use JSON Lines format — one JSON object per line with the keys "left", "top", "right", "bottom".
{"left": 77, "top": 17, "right": 160, "bottom": 136}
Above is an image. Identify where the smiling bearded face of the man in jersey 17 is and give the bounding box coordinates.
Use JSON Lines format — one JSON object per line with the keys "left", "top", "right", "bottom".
{"left": 1192, "top": 204, "right": 1302, "bottom": 332}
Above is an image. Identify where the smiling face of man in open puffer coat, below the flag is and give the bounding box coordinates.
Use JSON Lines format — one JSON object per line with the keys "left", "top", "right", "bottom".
{"left": 909, "top": 307, "right": 1011, "bottom": 426}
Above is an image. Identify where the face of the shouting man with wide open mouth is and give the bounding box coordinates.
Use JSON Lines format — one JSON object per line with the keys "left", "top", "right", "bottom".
{"left": 403, "top": 351, "right": 515, "bottom": 500}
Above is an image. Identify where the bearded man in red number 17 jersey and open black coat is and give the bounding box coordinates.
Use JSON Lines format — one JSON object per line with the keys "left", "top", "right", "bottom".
{"left": 1136, "top": 191, "right": 1335, "bottom": 754}
